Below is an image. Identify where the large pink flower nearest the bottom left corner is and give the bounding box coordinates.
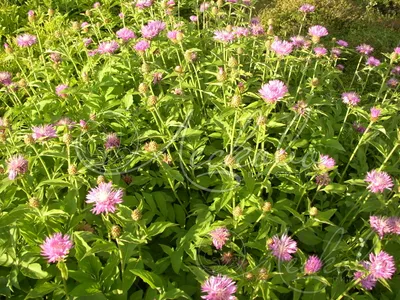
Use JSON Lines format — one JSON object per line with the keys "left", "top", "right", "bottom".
{"left": 40, "top": 233, "right": 73, "bottom": 263}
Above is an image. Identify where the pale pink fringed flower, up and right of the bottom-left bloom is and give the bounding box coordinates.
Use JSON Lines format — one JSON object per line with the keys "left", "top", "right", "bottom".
{"left": 86, "top": 182, "right": 123, "bottom": 215}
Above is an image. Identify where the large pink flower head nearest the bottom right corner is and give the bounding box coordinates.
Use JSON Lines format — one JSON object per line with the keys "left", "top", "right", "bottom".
{"left": 369, "top": 251, "right": 396, "bottom": 279}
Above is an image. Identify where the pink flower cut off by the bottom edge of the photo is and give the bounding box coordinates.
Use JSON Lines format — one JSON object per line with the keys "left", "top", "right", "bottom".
{"left": 201, "top": 275, "right": 236, "bottom": 300}
